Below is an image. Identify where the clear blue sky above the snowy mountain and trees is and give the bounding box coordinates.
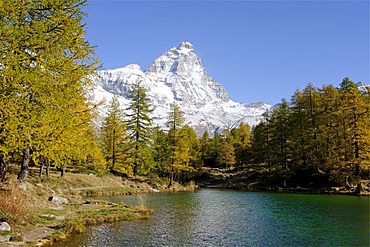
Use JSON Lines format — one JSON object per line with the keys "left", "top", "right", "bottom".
{"left": 84, "top": 0, "right": 370, "bottom": 104}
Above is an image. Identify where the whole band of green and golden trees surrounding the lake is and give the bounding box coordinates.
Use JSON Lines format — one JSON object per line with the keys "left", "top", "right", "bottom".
{"left": 0, "top": 0, "right": 370, "bottom": 191}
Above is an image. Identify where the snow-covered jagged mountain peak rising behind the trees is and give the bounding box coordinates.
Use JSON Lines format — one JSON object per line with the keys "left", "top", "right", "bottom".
{"left": 91, "top": 42, "right": 271, "bottom": 136}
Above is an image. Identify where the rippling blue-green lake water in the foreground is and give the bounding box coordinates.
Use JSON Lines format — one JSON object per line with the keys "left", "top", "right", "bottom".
{"left": 57, "top": 189, "right": 369, "bottom": 246}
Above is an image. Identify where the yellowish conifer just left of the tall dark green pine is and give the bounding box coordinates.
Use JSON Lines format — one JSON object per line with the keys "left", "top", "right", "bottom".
{"left": 100, "top": 97, "right": 133, "bottom": 175}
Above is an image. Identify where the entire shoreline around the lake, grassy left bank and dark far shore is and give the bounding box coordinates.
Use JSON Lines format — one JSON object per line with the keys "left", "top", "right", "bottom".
{"left": 0, "top": 169, "right": 370, "bottom": 246}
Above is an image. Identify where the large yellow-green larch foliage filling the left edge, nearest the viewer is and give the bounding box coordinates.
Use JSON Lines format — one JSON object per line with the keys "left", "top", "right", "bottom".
{"left": 0, "top": 0, "right": 97, "bottom": 181}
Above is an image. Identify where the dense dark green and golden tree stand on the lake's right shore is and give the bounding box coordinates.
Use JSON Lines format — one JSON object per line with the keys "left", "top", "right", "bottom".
{"left": 252, "top": 78, "right": 370, "bottom": 193}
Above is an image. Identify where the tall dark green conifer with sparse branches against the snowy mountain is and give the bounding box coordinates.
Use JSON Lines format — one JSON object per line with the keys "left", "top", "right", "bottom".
{"left": 126, "top": 81, "right": 153, "bottom": 176}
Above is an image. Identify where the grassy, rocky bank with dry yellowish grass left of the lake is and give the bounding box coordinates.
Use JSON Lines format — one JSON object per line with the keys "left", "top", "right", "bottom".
{"left": 0, "top": 165, "right": 195, "bottom": 246}
